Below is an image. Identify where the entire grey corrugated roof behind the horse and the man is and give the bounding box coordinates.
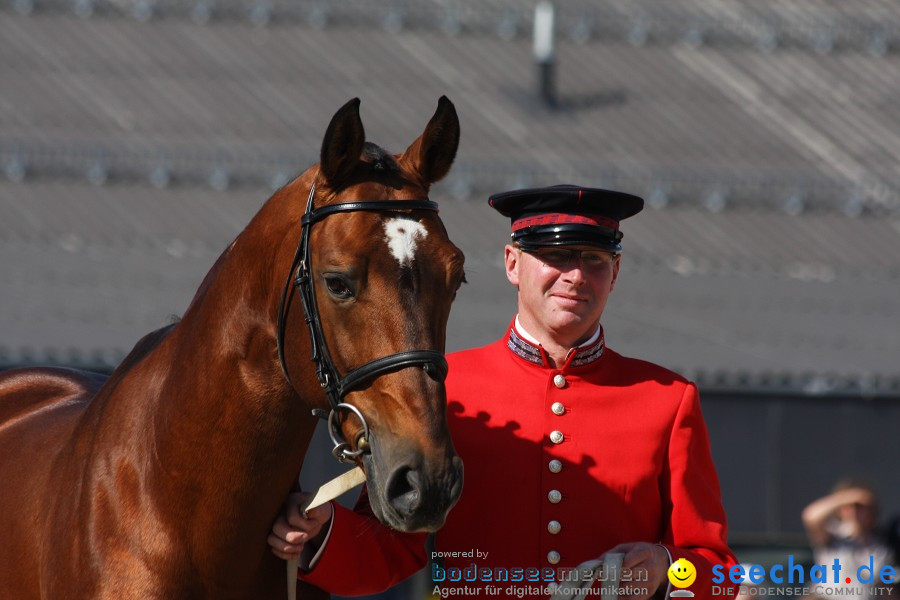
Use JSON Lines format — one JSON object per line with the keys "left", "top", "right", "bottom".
{"left": 0, "top": 0, "right": 900, "bottom": 396}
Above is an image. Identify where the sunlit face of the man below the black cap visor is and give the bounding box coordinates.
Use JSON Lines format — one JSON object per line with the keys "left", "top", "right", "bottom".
{"left": 505, "top": 245, "right": 621, "bottom": 347}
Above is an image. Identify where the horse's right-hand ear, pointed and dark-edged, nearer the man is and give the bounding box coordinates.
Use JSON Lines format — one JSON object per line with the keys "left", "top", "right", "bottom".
{"left": 403, "top": 96, "right": 459, "bottom": 184}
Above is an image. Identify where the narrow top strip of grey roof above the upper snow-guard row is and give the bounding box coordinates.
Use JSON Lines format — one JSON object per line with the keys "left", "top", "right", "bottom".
{"left": 8, "top": 0, "right": 898, "bottom": 53}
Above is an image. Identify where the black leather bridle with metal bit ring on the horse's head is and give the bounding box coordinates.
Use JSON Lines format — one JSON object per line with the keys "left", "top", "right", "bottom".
{"left": 276, "top": 183, "right": 447, "bottom": 462}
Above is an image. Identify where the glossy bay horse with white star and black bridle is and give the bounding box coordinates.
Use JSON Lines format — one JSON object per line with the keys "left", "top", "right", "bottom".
{"left": 0, "top": 97, "right": 464, "bottom": 600}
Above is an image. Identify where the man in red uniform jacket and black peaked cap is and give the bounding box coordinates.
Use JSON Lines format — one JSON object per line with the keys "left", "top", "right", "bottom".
{"left": 270, "top": 185, "right": 735, "bottom": 600}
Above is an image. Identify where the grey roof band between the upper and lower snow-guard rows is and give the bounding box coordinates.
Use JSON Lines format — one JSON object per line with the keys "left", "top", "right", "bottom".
{"left": 0, "top": 12, "right": 900, "bottom": 211}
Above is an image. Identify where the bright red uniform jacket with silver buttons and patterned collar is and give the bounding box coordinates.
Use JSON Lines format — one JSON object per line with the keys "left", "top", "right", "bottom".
{"left": 301, "top": 327, "right": 735, "bottom": 599}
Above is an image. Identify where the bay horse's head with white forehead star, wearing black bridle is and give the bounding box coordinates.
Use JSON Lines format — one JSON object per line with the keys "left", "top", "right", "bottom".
{"left": 276, "top": 97, "right": 464, "bottom": 531}
